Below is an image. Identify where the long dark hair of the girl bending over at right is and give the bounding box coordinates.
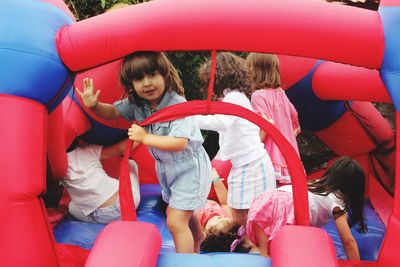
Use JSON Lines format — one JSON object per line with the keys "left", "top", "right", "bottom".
{"left": 308, "top": 157, "right": 367, "bottom": 233}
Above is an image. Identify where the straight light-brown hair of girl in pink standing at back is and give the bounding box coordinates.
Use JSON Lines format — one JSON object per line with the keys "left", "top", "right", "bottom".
{"left": 246, "top": 53, "right": 281, "bottom": 90}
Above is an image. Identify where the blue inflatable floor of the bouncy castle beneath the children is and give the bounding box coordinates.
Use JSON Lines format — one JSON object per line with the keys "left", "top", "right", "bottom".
{"left": 54, "top": 184, "right": 385, "bottom": 267}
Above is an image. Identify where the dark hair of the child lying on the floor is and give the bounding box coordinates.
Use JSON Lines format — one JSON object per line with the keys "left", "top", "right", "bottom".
{"left": 200, "top": 223, "right": 251, "bottom": 253}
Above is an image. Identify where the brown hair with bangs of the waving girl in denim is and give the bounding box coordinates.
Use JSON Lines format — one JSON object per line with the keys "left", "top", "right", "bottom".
{"left": 119, "top": 51, "right": 185, "bottom": 105}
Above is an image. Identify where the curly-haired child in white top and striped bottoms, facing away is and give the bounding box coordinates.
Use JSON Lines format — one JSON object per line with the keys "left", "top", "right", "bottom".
{"left": 196, "top": 52, "right": 276, "bottom": 228}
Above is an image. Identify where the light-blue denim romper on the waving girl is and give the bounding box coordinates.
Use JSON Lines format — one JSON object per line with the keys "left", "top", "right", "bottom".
{"left": 114, "top": 91, "right": 211, "bottom": 210}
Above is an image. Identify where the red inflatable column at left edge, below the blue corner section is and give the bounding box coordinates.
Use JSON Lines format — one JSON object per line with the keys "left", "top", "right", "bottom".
{"left": 0, "top": 95, "right": 57, "bottom": 267}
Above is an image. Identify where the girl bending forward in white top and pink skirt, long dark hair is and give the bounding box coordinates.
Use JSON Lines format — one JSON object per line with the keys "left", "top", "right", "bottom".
{"left": 246, "top": 157, "right": 367, "bottom": 260}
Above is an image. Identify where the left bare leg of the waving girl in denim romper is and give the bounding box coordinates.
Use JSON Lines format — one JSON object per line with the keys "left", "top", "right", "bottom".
{"left": 167, "top": 207, "right": 194, "bottom": 253}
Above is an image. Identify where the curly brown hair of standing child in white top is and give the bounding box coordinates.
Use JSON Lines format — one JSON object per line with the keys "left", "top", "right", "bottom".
{"left": 199, "top": 52, "right": 251, "bottom": 98}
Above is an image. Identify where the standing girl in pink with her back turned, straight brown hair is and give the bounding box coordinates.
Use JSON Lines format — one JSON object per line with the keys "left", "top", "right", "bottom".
{"left": 246, "top": 53, "right": 300, "bottom": 184}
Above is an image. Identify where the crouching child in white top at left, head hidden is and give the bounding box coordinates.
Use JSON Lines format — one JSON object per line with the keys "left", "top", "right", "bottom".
{"left": 62, "top": 140, "right": 140, "bottom": 223}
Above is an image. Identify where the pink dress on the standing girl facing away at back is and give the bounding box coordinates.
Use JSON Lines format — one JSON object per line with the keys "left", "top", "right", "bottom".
{"left": 251, "top": 88, "right": 300, "bottom": 183}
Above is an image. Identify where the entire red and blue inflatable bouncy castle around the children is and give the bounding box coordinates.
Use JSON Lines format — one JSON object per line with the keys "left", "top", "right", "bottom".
{"left": 0, "top": 0, "right": 400, "bottom": 267}
